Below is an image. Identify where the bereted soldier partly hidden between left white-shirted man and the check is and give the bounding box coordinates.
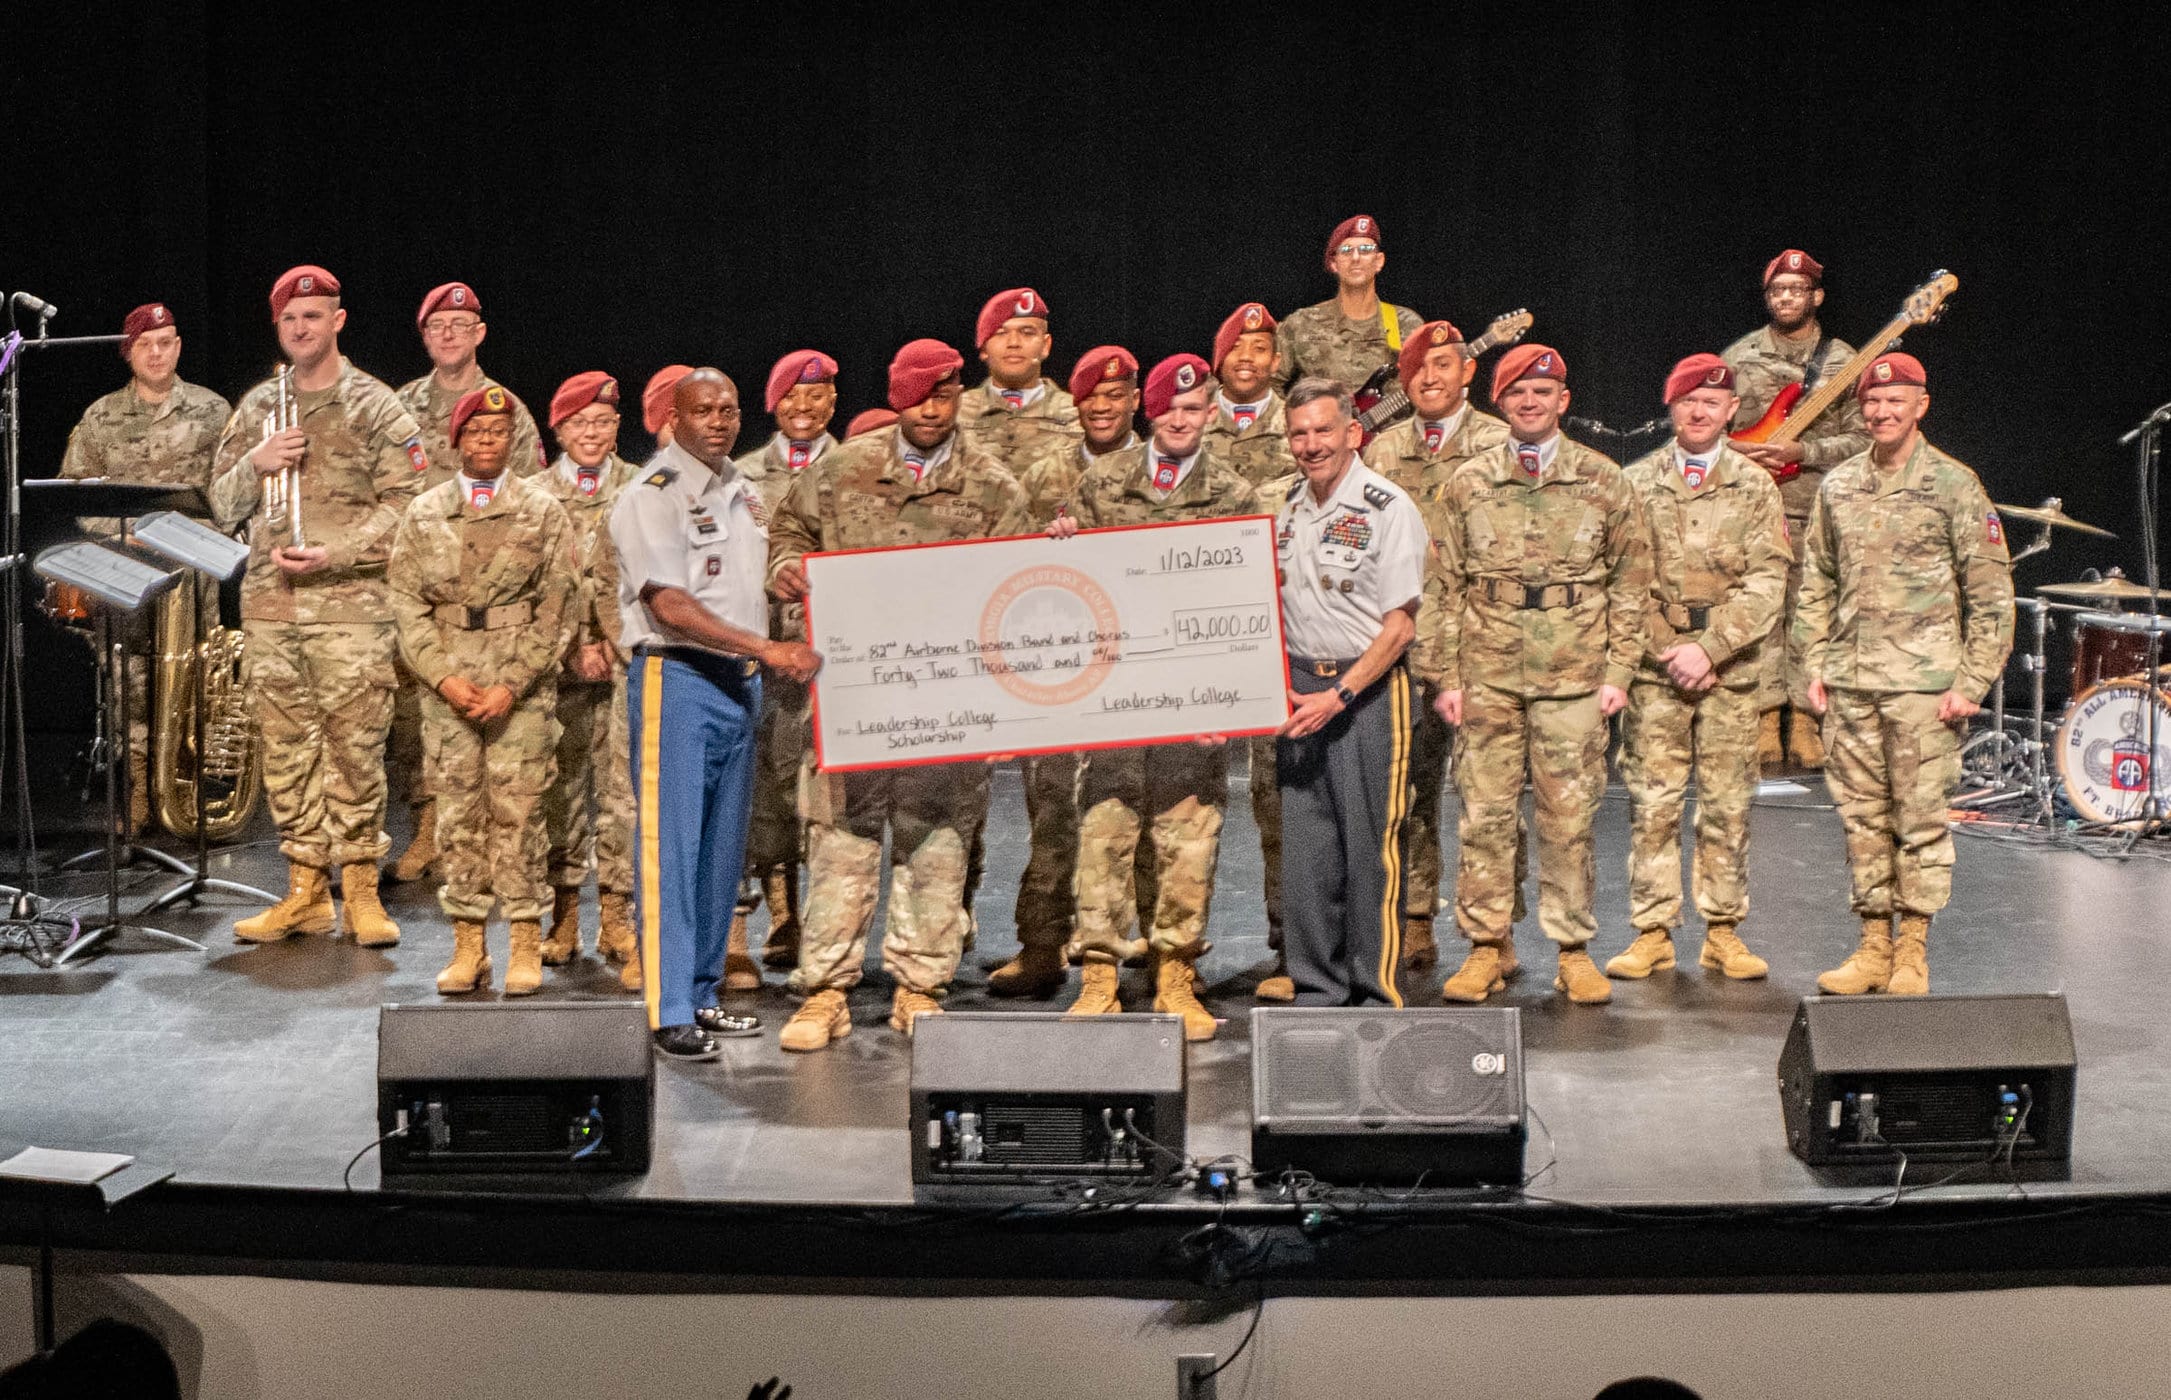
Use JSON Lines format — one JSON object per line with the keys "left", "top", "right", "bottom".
{"left": 723, "top": 349, "right": 836, "bottom": 992}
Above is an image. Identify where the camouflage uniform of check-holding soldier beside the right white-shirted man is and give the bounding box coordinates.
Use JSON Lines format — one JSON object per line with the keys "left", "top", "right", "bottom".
{"left": 1070, "top": 443, "right": 1259, "bottom": 962}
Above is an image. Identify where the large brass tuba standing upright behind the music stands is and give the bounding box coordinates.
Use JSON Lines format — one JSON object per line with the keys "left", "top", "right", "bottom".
{"left": 150, "top": 571, "right": 263, "bottom": 842}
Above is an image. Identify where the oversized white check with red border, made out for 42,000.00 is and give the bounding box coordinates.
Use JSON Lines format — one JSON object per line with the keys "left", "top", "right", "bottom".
{"left": 805, "top": 514, "right": 1290, "bottom": 773}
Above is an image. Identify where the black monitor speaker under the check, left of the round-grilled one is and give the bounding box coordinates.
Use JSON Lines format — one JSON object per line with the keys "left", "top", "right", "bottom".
{"left": 910, "top": 1011, "right": 1183, "bottom": 1183}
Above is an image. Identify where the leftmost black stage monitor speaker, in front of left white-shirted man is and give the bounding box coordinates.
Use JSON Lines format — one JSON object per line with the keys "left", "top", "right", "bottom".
{"left": 378, "top": 1001, "right": 656, "bottom": 1176}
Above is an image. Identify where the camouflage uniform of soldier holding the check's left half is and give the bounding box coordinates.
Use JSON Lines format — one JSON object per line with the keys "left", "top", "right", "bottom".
{"left": 769, "top": 432, "right": 1023, "bottom": 996}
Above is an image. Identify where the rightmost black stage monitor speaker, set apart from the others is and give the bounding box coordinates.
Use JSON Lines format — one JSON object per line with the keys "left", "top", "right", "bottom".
{"left": 1778, "top": 994, "right": 2075, "bottom": 1166}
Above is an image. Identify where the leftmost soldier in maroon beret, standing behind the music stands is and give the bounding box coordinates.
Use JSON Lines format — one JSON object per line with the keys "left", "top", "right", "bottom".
{"left": 61, "top": 302, "right": 232, "bottom": 831}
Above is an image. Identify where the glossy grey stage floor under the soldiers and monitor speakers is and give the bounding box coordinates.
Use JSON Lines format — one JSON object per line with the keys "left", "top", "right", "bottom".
{"left": 0, "top": 768, "right": 2171, "bottom": 1207}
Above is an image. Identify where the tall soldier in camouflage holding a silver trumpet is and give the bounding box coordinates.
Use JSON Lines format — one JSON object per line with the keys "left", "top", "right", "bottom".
{"left": 211, "top": 267, "right": 430, "bottom": 946}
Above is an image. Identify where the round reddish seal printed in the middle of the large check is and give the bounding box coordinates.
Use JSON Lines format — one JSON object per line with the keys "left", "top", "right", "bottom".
{"left": 979, "top": 564, "right": 1122, "bottom": 705}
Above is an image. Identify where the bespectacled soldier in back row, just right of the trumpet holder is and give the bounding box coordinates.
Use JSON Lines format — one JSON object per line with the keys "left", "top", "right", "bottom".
{"left": 386, "top": 282, "right": 549, "bottom": 881}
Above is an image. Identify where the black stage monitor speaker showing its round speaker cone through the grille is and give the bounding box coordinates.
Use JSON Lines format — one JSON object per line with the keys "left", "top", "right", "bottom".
{"left": 1250, "top": 1007, "right": 1524, "bottom": 1185}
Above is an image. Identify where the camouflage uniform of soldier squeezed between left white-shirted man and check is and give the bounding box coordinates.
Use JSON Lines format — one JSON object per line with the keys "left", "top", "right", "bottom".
{"left": 732, "top": 432, "right": 836, "bottom": 944}
